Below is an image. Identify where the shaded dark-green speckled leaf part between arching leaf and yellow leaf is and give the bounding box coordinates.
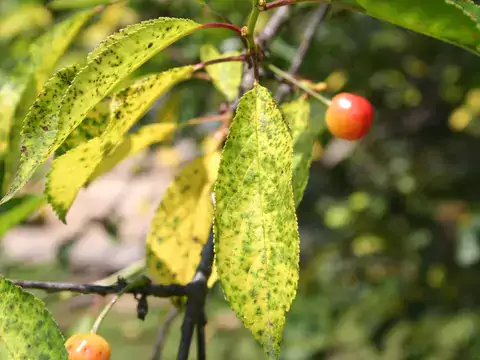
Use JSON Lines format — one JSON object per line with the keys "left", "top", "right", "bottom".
{"left": 55, "top": 101, "right": 110, "bottom": 157}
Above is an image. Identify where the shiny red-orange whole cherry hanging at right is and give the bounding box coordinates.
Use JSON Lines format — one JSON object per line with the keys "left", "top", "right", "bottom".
{"left": 325, "top": 93, "right": 373, "bottom": 140}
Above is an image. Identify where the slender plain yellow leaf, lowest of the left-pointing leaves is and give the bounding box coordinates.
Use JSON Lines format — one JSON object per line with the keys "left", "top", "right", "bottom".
{"left": 89, "top": 123, "right": 177, "bottom": 181}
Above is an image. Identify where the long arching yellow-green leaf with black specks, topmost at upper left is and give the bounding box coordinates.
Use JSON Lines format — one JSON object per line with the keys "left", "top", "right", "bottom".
{"left": 53, "top": 18, "right": 200, "bottom": 150}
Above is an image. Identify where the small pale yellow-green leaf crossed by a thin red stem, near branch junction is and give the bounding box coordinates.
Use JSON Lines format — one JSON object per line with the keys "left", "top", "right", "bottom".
{"left": 200, "top": 45, "right": 243, "bottom": 101}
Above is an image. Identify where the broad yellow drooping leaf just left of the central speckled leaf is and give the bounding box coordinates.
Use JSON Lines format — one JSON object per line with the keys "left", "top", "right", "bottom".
{"left": 147, "top": 152, "right": 220, "bottom": 285}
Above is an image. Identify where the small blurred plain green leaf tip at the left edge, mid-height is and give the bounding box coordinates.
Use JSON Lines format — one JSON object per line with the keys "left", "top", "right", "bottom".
{"left": 0, "top": 195, "right": 45, "bottom": 240}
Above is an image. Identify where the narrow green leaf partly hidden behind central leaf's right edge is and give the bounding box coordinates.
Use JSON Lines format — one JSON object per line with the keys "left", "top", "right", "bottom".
{"left": 282, "top": 98, "right": 315, "bottom": 207}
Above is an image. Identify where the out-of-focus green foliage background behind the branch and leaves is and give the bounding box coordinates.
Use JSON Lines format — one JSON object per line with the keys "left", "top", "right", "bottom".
{"left": 0, "top": 0, "right": 480, "bottom": 360}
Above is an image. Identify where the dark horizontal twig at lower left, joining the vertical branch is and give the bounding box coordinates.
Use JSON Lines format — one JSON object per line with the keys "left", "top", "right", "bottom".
{"left": 12, "top": 280, "right": 188, "bottom": 298}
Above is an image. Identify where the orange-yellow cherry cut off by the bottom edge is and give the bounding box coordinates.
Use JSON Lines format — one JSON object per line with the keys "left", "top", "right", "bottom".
{"left": 65, "top": 333, "right": 110, "bottom": 360}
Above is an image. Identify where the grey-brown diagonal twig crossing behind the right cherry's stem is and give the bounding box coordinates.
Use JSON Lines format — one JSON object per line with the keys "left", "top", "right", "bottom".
{"left": 275, "top": 3, "right": 330, "bottom": 102}
